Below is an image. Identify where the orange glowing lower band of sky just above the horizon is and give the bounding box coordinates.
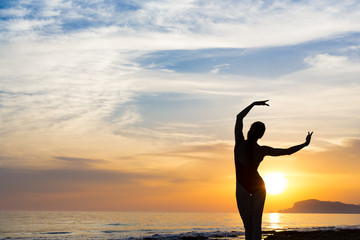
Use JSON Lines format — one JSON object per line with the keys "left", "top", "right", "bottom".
{"left": 0, "top": 126, "right": 360, "bottom": 211}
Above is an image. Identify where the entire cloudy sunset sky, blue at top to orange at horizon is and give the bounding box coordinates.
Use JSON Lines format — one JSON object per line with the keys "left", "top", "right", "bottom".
{"left": 0, "top": 0, "right": 360, "bottom": 212}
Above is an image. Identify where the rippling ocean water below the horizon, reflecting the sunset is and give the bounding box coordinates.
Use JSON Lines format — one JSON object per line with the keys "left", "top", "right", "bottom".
{"left": 0, "top": 211, "right": 360, "bottom": 240}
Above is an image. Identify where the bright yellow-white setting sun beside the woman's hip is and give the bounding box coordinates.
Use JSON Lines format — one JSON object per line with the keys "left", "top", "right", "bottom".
{"left": 263, "top": 172, "right": 288, "bottom": 195}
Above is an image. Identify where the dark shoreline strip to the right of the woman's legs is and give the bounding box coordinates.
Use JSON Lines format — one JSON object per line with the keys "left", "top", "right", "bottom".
{"left": 263, "top": 229, "right": 360, "bottom": 240}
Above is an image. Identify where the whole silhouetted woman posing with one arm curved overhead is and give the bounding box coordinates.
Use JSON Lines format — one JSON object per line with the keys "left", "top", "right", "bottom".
{"left": 234, "top": 100, "right": 313, "bottom": 240}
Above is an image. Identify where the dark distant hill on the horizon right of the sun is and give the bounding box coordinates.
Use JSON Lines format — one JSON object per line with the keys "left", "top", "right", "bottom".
{"left": 279, "top": 199, "right": 360, "bottom": 213}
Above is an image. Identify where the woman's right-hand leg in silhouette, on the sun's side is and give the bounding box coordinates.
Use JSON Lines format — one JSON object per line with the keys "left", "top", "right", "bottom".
{"left": 252, "top": 189, "right": 266, "bottom": 240}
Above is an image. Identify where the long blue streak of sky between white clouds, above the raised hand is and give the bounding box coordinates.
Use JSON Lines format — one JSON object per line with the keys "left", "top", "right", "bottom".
{"left": 138, "top": 33, "right": 359, "bottom": 78}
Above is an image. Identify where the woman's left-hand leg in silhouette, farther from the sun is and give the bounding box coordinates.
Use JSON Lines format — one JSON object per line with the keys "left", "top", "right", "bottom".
{"left": 236, "top": 183, "right": 253, "bottom": 240}
